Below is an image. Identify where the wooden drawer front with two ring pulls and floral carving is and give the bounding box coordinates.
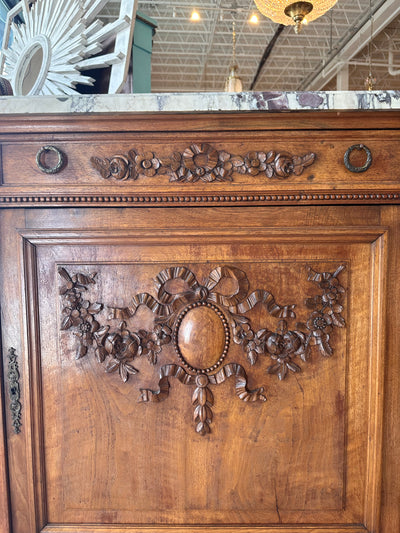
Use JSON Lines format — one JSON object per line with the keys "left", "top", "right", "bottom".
{"left": 2, "top": 131, "right": 400, "bottom": 205}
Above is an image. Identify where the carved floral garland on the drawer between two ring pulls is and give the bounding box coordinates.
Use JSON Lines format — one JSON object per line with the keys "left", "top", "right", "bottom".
{"left": 90, "top": 143, "right": 316, "bottom": 183}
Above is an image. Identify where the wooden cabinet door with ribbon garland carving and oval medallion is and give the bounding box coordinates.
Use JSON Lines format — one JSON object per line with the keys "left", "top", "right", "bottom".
{"left": 1, "top": 206, "right": 399, "bottom": 533}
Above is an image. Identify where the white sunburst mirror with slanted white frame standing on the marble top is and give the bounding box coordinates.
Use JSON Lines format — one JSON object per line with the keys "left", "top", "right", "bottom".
{"left": 0, "top": 0, "right": 138, "bottom": 96}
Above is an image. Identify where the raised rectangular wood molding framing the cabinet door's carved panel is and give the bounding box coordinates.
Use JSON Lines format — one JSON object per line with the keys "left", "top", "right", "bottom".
{"left": 2, "top": 217, "right": 387, "bottom": 533}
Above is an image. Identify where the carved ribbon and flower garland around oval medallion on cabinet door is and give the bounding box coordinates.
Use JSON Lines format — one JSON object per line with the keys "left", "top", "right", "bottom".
{"left": 59, "top": 265, "right": 345, "bottom": 435}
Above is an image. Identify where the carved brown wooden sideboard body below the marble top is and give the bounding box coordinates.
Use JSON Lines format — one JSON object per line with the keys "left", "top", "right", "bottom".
{"left": 0, "top": 111, "right": 400, "bottom": 533}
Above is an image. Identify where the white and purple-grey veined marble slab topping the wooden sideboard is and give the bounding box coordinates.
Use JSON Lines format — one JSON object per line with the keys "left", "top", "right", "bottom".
{"left": 0, "top": 91, "right": 400, "bottom": 113}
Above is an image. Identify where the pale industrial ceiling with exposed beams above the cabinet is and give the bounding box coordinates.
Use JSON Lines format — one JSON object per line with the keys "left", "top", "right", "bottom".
{"left": 101, "top": 0, "right": 400, "bottom": 92}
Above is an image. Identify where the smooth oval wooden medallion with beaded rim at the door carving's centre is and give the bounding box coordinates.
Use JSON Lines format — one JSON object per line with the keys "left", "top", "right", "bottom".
{"left": 174, "top": 302, "right": 229, "bottom": 373}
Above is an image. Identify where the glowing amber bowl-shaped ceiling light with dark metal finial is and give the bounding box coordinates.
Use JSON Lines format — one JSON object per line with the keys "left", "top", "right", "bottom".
{"left": 254, "top": 0, "right": 337, "bottom": 33}
